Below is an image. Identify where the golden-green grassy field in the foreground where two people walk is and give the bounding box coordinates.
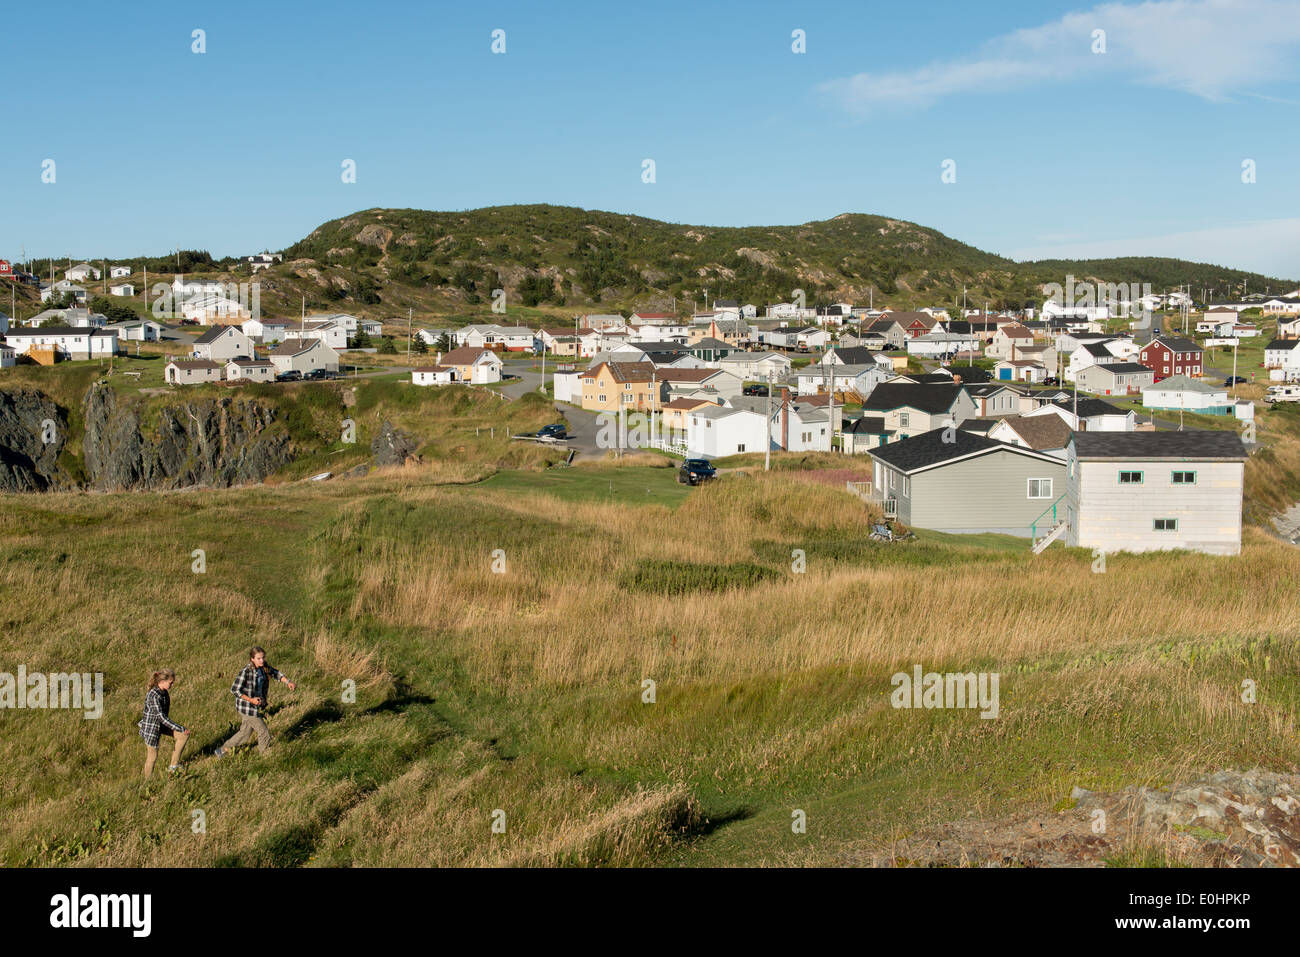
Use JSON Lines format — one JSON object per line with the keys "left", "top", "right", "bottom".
{"left": 0, "top": 456, "right": 1300, "bottom": 866}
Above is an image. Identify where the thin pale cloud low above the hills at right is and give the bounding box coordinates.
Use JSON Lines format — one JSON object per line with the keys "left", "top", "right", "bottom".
{"left": 1004, "top": 218, "right": 1300, "bottom": 283}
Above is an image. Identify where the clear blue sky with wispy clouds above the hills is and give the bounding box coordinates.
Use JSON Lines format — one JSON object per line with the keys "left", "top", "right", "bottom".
{"left": 0, "top": 0, "right": 1300, "bottom": 277}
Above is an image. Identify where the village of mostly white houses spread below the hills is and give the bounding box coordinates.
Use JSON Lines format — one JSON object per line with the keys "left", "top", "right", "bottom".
{"left": 0, "top": 261, "right": 1300, "bottom": 555}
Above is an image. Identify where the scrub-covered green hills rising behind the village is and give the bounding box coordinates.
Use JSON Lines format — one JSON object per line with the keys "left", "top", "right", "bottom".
{"left": 15, "top": 205, "right": 1296, "bottom": 321}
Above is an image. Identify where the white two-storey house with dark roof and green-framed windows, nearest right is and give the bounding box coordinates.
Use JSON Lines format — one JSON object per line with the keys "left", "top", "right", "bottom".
{"left": 1065, "top": 429, "right": 1245, "bottom": 555}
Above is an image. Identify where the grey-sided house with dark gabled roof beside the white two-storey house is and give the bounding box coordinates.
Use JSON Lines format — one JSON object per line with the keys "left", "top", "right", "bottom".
{"left": 870, "top": 429, "right": 1067, "bottom": 538}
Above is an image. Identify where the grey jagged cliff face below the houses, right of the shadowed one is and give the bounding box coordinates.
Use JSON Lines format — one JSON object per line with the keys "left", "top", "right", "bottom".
{"left": 82, "top": 385, "right": 294, "bottom": 490}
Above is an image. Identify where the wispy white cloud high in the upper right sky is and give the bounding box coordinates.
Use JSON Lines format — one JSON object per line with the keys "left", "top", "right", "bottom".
{"left": 818, "top": 0, "right": 1300, "bottom": 114}
